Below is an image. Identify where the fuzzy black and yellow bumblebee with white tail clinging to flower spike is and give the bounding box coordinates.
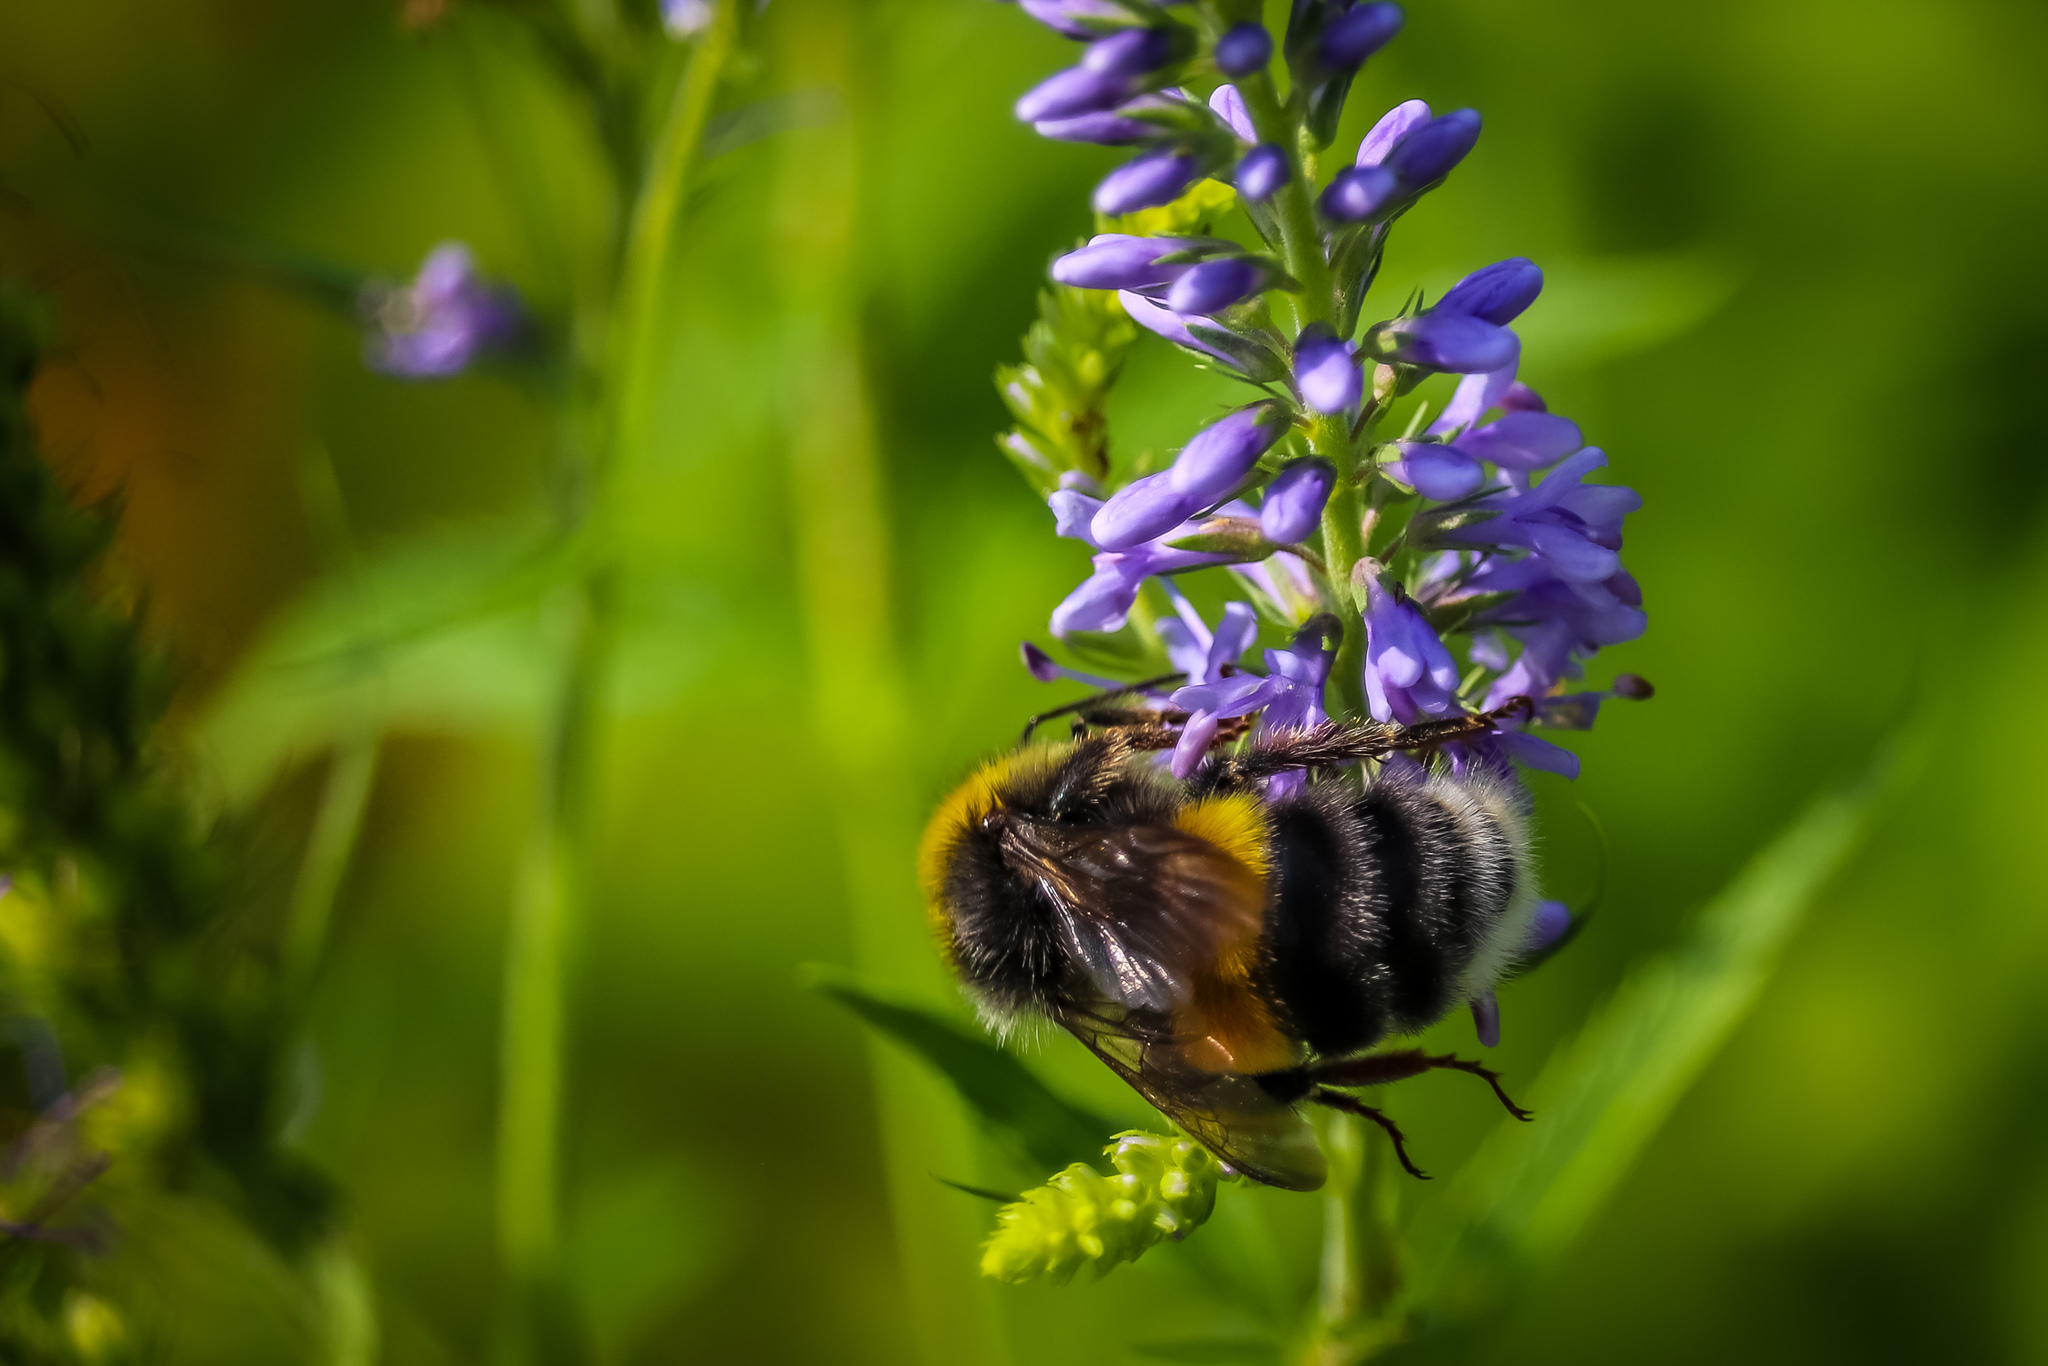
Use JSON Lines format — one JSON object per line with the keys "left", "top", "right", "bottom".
{"left": 920, "top": 698, "right": 1536, "bottom": 1190}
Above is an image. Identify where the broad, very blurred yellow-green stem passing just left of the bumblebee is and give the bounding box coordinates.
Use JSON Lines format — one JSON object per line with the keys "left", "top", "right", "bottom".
{"left": 772, "top": 4, "right": 1006, "bottom": 1366}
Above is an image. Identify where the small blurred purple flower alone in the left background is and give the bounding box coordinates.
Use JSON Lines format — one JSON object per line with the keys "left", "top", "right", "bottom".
{"left": 365, "top": 242, "right": 526, "bottom": 379}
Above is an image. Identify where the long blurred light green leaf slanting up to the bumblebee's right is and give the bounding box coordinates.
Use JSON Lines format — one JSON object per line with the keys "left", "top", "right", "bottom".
{"left": 1411, "top": 729, "right": 1925, "bottom": 1317}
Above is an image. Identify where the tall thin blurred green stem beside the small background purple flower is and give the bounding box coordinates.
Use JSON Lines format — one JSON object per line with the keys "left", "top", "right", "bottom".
{"left": 498, "top": 0, "right": 739, "bottom": 1362}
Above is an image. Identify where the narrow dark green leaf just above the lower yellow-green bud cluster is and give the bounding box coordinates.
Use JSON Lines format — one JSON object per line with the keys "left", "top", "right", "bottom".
{"left": 803, "top": 963, "right": 1122, "bottom": 1171}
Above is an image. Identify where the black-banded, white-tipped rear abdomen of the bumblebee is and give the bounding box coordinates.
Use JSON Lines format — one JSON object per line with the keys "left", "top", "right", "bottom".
{"left": 1268, "top": 774, "right": 1534, "bottom": 1057}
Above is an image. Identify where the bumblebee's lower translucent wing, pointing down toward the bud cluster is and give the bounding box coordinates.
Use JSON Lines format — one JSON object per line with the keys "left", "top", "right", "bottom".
{"left": 1059, "top": 1012, "right": 1327, "bottom": 1190}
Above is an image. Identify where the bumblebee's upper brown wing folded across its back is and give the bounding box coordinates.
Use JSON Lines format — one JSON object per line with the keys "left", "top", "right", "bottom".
{"left": 1004, "top": 823, "right": 1266, "bottom": 1012}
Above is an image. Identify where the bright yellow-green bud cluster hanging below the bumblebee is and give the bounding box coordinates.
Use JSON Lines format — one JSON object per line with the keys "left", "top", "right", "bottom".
{"left": 981, "top": 1133, "right": 1223, "bottom": 1284}
